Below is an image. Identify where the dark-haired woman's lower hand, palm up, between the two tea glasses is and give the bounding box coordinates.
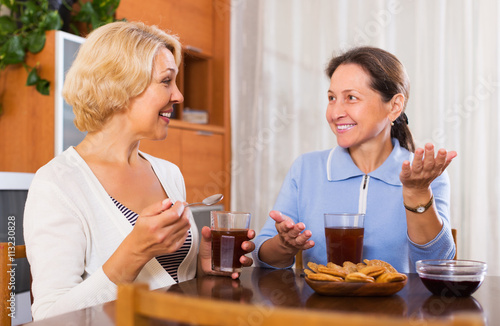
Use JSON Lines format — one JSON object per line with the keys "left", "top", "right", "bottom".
{"left": 269, "top": 211, "right": 314, "bottom": 255}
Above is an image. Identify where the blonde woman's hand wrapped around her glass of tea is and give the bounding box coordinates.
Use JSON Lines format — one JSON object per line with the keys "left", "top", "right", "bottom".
{"left": 198, "top": 226, "right": 255, "bottom": 279}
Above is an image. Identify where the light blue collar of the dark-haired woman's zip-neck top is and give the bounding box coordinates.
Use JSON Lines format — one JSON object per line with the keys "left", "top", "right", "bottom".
{"left": 326, "top": 138, "right": 413, "bottom": 186}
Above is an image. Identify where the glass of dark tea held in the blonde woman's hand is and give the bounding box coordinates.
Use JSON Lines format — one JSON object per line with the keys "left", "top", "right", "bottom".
{"left": 210, "top": 211, "right": 251, "bottom": 272}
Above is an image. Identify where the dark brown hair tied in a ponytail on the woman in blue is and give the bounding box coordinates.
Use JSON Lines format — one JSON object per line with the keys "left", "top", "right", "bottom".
{"left": 326, "top": 46, "right": 415, "bottom": 152}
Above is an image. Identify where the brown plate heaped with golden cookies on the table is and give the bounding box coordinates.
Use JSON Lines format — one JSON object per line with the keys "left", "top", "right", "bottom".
{"left": 304, "top": 259, "right": 408, "bottom": 297}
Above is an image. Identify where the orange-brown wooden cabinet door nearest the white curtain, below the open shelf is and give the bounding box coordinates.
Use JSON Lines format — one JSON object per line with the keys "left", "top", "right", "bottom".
{"left": 181, "top": 130, "right": 227, "bottom": 202}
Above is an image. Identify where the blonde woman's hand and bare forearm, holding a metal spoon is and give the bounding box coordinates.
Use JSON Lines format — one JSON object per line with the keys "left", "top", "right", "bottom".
{"left": 102, "top": 199, "right": 191, "bottom": 284}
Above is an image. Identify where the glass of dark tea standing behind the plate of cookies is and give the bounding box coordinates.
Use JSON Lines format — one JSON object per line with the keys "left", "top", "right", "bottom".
{"left": 325, "top": 213, "right": 365, "bottom": 266}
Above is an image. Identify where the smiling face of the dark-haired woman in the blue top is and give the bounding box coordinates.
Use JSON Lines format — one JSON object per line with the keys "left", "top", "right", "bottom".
{"left": 326, "top": 64, "right": 399, "bottom": 149}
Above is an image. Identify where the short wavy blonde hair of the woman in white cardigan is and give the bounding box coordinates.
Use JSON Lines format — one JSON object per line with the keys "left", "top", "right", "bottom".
{"left": 62, "top": 22, "right": 181, "bottom": 132}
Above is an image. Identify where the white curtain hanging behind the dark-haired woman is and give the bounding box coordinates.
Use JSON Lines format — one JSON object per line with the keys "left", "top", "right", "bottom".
{"left": 231, "top": 0, "right": 500, "bottom": 275}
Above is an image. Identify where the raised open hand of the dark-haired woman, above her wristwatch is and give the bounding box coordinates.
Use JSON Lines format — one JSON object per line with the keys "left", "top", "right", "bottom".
{"left": 399, "top": 143, "right": 457, "bottom": 192}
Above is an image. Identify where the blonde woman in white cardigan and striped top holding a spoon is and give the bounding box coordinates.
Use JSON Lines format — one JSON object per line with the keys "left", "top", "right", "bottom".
{"left": 24, "top": 22, "right": 255, "bottom": 320}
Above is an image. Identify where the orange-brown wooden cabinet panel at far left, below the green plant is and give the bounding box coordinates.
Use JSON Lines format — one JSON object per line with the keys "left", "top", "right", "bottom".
{"left": 0, "top": 31, "right": 55, "bottom": 172}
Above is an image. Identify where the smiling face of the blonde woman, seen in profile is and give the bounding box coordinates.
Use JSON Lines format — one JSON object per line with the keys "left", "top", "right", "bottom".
{"left": 127, "top": 47, "right": 184, "bottom": 140}
